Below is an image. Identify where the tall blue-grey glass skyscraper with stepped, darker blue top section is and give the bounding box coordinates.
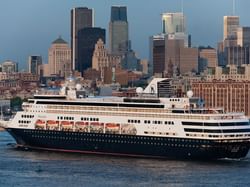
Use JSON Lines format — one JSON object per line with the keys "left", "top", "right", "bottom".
{"left": 109, "top": 6, "right": 129, "bottom": 55}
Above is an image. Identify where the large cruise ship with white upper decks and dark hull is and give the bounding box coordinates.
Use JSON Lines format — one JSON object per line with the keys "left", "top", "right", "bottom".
{"left": 1, "top": 77, "right": 250, "bottom": 160}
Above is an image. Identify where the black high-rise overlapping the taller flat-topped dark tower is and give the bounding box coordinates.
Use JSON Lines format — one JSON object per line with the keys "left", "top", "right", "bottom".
{"left": 76, "top": 27, "right": 105, "bottom": 73}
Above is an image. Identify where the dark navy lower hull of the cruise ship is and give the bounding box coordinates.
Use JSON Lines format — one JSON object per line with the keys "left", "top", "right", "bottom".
{"left": 7, "top": 128, "right": 250, "bottom": 159}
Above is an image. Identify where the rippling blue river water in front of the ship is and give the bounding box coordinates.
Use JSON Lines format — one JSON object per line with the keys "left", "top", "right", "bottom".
{"left": 0, "top": 132, "right": 250, "bottom": 187}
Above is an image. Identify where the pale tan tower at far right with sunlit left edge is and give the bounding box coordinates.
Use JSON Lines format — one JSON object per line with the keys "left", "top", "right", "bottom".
{"left": 223, "top": 16, "right": 240, "bottom": 40}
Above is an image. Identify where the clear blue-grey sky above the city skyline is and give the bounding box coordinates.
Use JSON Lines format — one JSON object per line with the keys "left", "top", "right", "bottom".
{"left": 0, "top": 0, "right": 250, "bottom": 70}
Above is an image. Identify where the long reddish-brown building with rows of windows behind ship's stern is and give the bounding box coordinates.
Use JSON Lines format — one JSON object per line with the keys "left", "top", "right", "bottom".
{"left": 192, "top": 79, "right": 250, "bottom": 118}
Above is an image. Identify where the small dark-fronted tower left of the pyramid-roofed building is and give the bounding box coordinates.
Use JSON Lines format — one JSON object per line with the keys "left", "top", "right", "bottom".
{"left": 28, "top": 55, "right": 42, "bottom": 75}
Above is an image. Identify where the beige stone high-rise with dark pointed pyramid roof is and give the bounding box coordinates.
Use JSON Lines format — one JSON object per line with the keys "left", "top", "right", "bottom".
{"left": 48, "top": 37, "right": 71, "bottom": 77}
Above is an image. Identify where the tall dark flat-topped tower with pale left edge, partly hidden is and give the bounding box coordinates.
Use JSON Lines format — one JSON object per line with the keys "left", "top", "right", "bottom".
{"left": 71, "top": 7, "right": 94, "bottom": 70}
